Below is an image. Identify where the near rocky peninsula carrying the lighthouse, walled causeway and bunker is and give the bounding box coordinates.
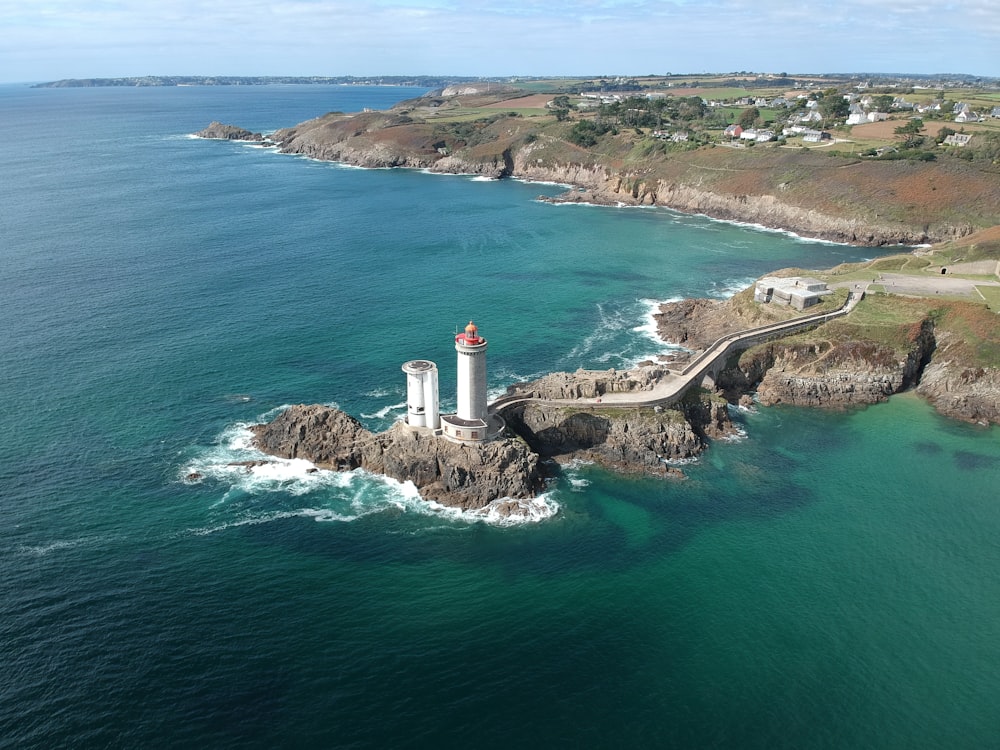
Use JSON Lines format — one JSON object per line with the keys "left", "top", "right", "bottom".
{"left": 242, "top": 229, "right": 1000, "bottom": 515}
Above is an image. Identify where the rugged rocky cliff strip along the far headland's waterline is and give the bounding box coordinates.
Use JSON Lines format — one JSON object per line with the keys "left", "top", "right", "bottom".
{"left": 197, "top": 116, "right": 976, "bottom": 246}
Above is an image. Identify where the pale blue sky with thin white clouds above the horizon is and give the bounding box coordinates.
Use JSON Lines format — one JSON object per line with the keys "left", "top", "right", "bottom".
{"left": 0, "top": 0, "right": 1000, "bottom": 83}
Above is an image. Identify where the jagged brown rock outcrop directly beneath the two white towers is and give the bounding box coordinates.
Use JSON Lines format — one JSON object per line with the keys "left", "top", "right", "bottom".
{"left": 253, "top": 405, "right": 542, "bottom": 510}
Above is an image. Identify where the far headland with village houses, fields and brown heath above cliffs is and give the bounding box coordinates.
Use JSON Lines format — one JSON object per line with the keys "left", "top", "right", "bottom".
{"left": 197, "top": 72, "right": 1000, "bottom": 245}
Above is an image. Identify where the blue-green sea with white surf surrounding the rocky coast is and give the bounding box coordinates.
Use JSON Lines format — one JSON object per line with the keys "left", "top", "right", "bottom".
{"left": 0, "top": 85, "right": 1000, "bottom": 749}
